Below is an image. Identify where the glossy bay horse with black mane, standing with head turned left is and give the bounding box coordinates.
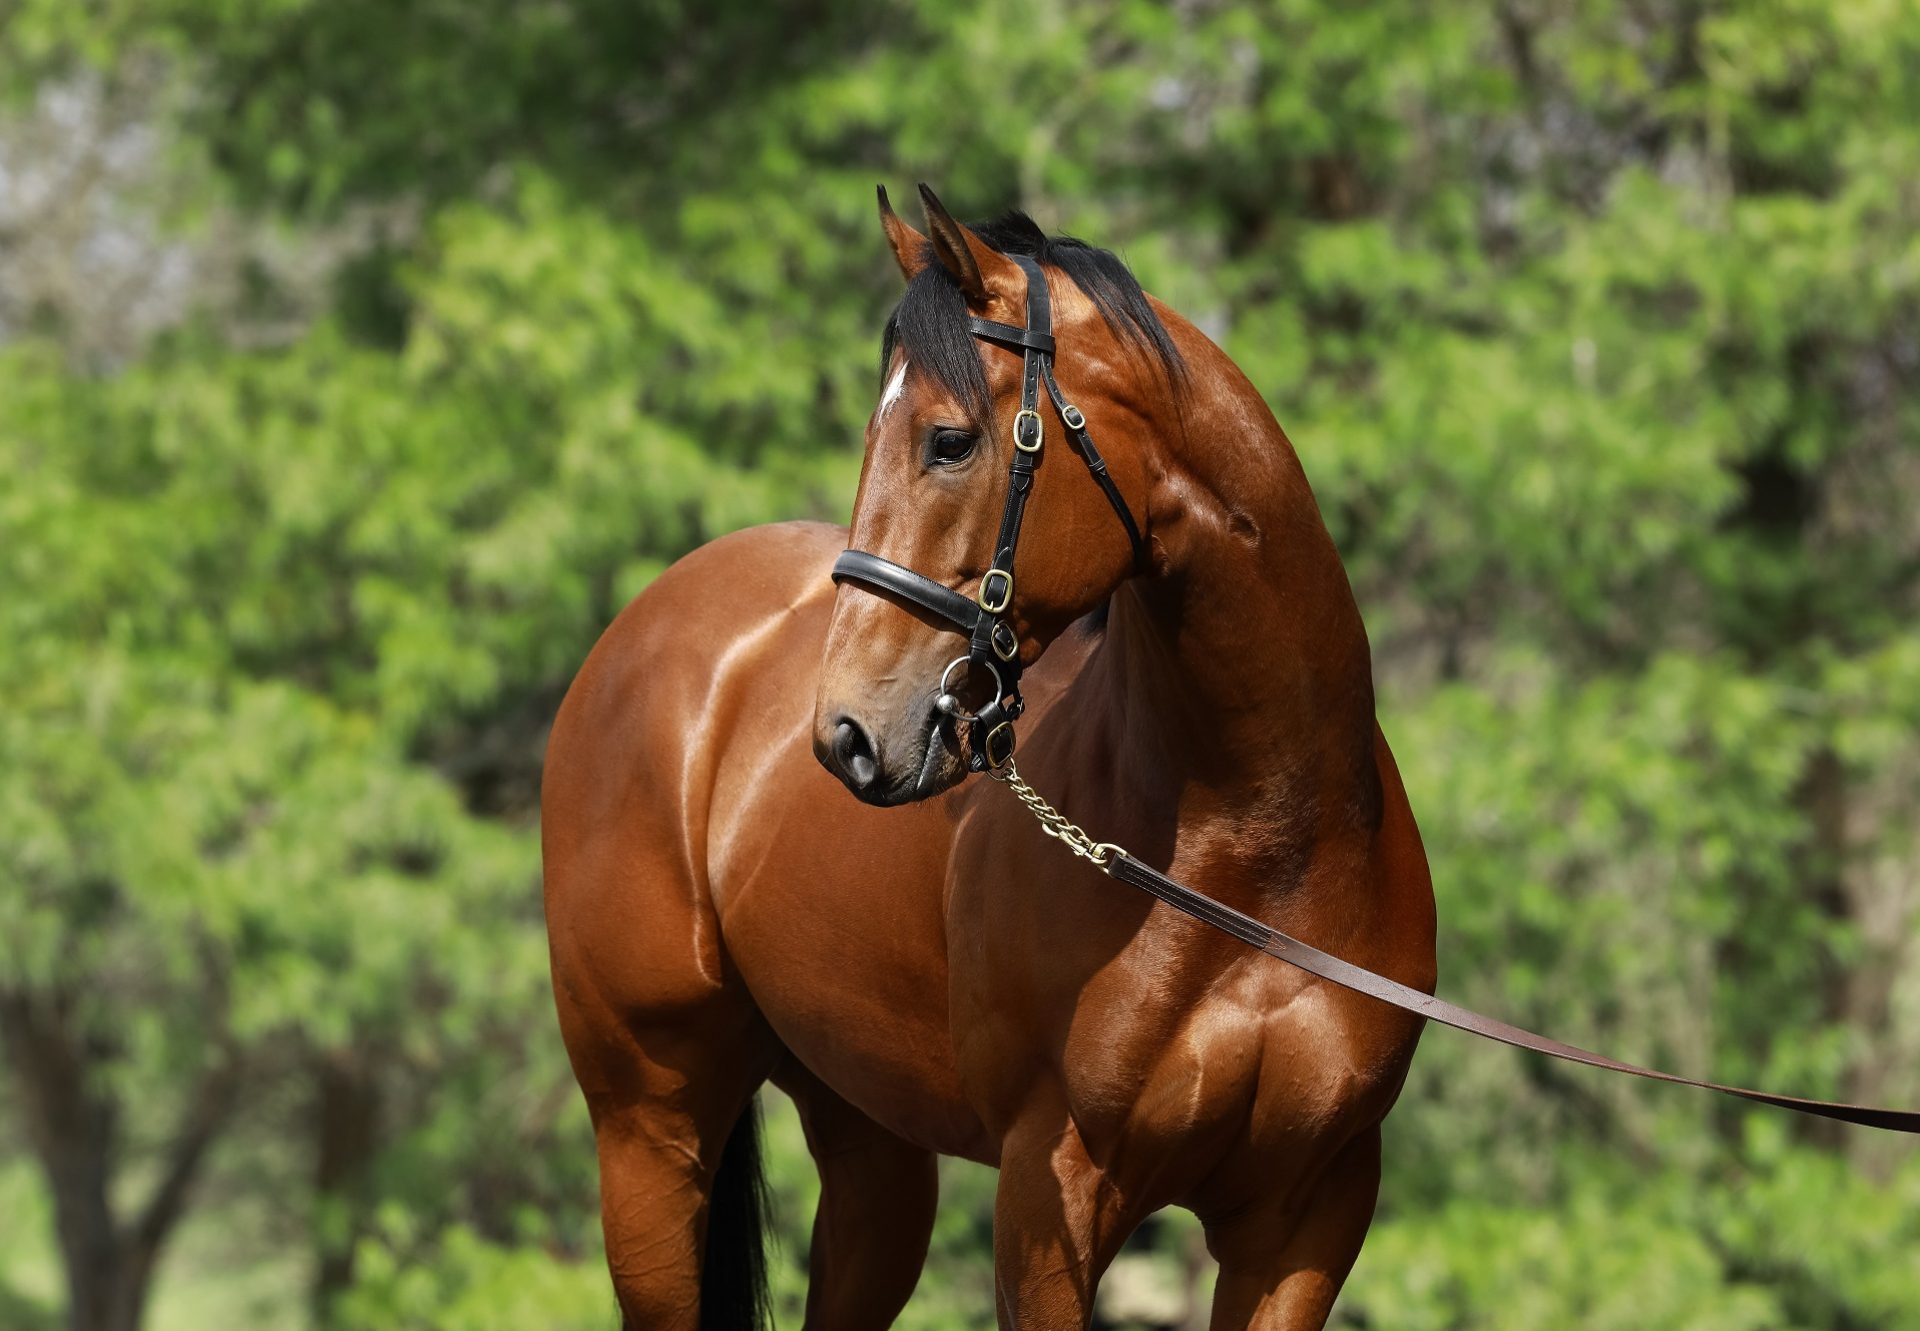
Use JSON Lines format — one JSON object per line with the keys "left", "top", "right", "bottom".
{"left": 541, "top": 186, "right": 1434, "bottom": 1331}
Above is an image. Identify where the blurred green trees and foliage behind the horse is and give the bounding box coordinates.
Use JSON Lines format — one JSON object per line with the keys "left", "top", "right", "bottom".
{"left": 0, "top": 0, "right": 1920, "bottom": 1331}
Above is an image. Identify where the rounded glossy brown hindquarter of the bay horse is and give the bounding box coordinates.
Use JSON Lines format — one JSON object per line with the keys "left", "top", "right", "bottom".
{"left": 541, "top": 522, "right": 845, "bottom": 1014}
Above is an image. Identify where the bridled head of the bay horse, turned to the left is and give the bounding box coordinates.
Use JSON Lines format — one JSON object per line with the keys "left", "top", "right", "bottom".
{"left": 814, "top": 186, "right": 1181, "bottom": 805}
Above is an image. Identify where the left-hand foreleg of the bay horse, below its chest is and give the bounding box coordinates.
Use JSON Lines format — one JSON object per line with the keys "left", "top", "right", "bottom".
{"left": 993, "top": 1118, "right": 1139, "bottom": 1331}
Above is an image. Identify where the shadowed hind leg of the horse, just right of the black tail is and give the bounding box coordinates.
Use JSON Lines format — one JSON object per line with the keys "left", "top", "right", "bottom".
{"left": 774, "top": 1058, "right": 939, "bottom": 1331}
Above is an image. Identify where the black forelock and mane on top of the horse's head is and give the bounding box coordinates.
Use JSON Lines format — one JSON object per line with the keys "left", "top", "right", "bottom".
{"left": 879, "top": 211, "right": 1185, "bottom": 421}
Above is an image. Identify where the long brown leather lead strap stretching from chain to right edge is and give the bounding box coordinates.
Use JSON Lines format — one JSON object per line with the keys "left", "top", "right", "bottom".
{"left": 1106, "top": 853, "right": 1920, "bottom": 1133}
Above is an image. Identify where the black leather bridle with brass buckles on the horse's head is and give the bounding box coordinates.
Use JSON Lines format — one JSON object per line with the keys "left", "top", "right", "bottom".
{"left": 833, "top": 254, "right": 1146, "bottom": 772}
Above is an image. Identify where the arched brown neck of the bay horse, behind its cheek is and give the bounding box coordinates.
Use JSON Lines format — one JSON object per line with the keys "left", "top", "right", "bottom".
{"left": 1108, "top": 321, "right": 1380, "bottom": 880}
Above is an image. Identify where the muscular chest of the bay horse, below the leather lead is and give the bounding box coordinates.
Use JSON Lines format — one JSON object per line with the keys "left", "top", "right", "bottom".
{"left": 950, "top": 860, "right": 1384, "bottom": 1200}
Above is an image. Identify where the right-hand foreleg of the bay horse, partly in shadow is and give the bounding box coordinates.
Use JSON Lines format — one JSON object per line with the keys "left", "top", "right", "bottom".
{"left": 1206, "top": 1127, "right": 1380, "bottom": 1331}
